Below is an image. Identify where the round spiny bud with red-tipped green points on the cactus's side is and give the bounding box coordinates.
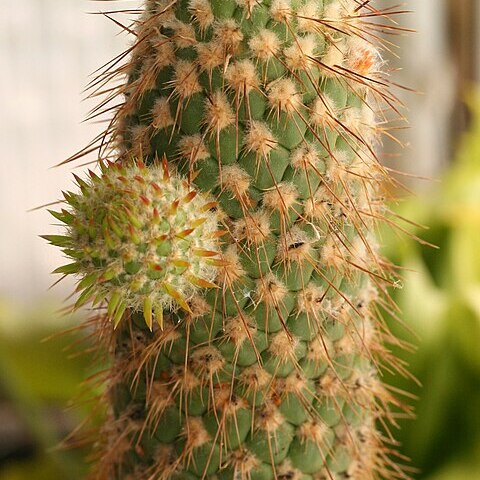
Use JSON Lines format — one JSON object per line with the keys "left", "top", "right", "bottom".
{"left": 46, "top": 162, "right": 219, "bottom": 328}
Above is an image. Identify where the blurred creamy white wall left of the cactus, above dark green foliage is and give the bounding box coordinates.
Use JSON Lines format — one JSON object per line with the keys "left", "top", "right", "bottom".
{"left": 0, "top": 0, "right": 132, "bottom": 303}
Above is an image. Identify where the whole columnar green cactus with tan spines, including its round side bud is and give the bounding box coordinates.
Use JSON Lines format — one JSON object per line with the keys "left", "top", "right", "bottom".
{"left": 47, "top": 0, "right": 407, "bottom": 480}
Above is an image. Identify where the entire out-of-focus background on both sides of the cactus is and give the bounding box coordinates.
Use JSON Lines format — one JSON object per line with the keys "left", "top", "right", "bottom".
{"left": 0, "top": 0, "right": 480, "bottom": 480}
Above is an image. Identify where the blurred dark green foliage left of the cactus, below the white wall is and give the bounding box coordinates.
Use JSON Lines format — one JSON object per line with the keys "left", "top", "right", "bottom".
{"left": 0, "top": 301, "right": 90, "bottom": 480}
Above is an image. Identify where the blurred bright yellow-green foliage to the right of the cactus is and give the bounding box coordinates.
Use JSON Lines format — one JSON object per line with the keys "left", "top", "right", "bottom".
{"left": 383, "top": 93, "right": 480, "bottom": 480}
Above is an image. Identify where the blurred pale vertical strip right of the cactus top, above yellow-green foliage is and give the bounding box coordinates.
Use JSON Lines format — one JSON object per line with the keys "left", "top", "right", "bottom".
{"left": 392, "top": 0, "right": 456, "bottom": 182}
